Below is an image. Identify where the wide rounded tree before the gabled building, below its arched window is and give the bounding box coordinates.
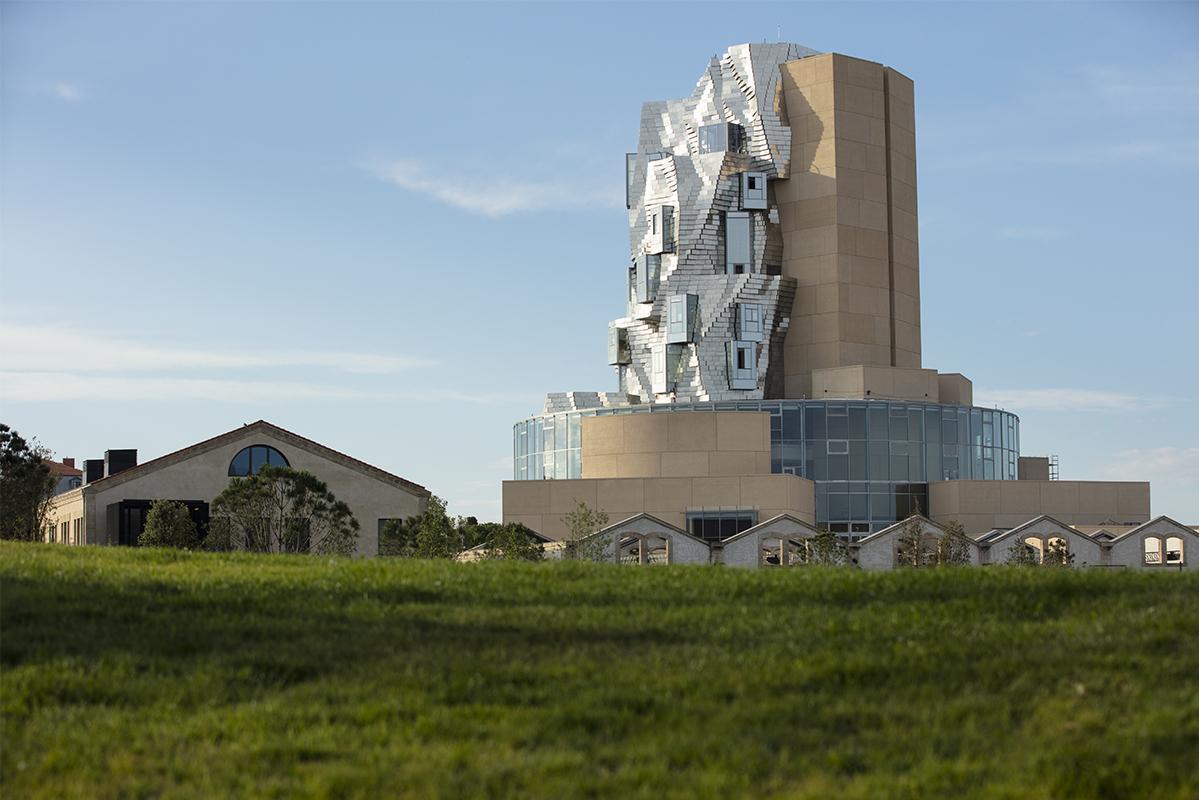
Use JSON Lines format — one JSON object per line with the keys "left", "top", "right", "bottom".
{"left": 212, "top": 464, "right": 359, "bottom": 555}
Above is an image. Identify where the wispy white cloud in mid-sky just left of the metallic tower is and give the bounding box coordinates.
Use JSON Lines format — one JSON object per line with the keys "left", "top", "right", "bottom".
{"left": 359, "top": 158, "right": 621, "bottom": 217}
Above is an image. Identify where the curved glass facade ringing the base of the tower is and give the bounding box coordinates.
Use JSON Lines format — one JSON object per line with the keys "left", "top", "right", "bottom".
{"left": 512, "top": 401, "right": 1020, "bottom": 536}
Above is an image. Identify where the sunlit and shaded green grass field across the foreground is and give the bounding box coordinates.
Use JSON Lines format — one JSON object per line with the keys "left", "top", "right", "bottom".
{"left": 7, "top": 543, "right": 1199, "bottom": 799}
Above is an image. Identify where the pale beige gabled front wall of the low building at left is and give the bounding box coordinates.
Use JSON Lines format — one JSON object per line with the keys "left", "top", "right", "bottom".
{"left": 85, "top": 431, "right": 424, "bottom": 555}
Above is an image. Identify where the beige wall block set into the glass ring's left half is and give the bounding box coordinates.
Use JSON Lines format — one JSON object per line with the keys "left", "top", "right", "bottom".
{"left": 582, "top": 411, "right": 770, "bottom": 477}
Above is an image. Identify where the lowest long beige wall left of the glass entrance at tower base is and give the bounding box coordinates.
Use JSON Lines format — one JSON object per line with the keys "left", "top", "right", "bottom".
{"left": 504, "top": 479, "right": 815, "bottom": 539}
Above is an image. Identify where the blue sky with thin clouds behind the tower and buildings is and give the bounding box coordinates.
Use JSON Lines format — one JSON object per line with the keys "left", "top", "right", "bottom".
{"left": 0, "top": 2, "right": 1199, "bottom": 523}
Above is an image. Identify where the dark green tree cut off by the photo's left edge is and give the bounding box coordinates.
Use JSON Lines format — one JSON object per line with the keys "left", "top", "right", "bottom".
{"left": 0, "top": 422, "right": 56, "bottom": 541}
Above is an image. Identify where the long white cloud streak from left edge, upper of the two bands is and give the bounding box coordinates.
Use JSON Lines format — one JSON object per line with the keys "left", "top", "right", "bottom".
{"left": 0, "top": 323, "right": 434, "bottom": 374}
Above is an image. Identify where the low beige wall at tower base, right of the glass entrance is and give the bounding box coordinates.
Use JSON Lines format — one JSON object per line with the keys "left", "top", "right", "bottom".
{"left": 928, "top": 481, "right": 1149, "bottom": 534}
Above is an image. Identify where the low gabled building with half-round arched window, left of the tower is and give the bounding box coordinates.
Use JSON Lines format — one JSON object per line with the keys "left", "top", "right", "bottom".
{"left": 46, "top": 420, "right": 429, "bottom": 555}
